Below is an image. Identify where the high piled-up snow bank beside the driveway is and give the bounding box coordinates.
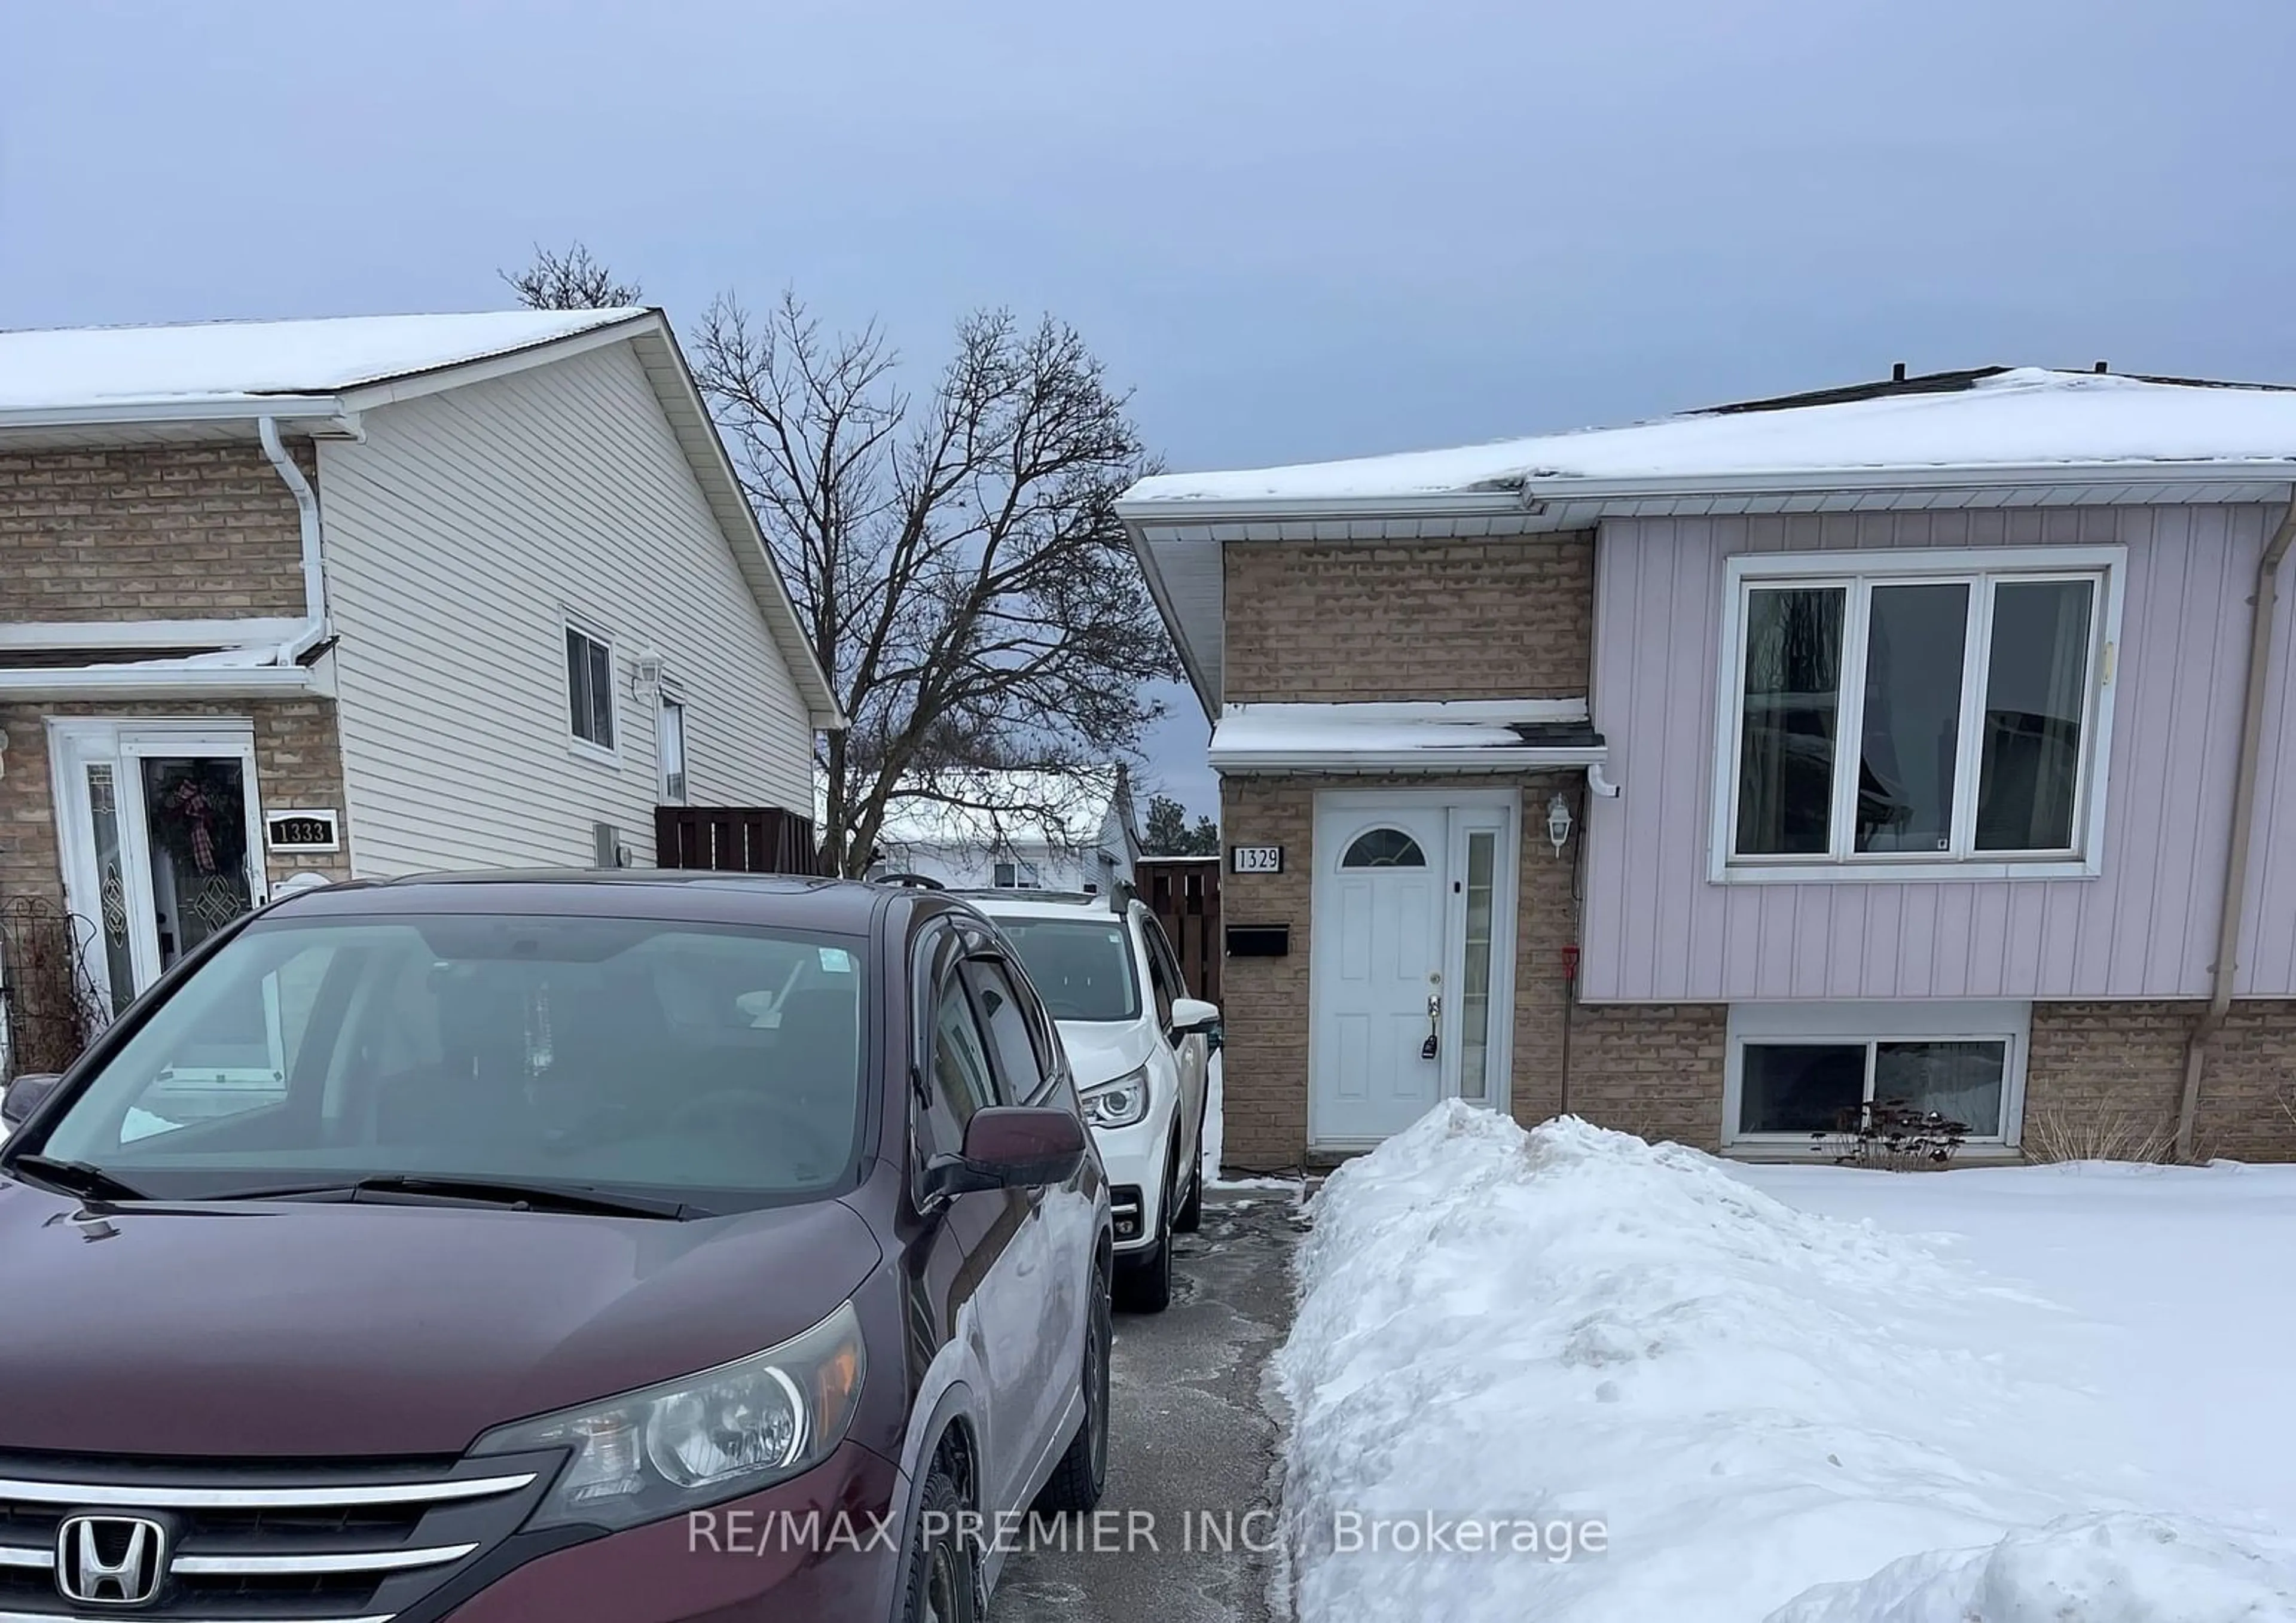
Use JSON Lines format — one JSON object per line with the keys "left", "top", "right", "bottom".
{"left": 1277, "top": 1104, "right": 2287, "bottom": 1623}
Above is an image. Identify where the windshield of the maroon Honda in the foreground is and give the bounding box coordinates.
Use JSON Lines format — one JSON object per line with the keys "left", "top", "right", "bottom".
{"left": 36, "top": 914, "right": 863, "bottom": 1210}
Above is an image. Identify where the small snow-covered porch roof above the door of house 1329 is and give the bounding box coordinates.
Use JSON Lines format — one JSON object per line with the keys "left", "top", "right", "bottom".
{"left": 1210, "top": 698, "right": 1607, "bottom": 771}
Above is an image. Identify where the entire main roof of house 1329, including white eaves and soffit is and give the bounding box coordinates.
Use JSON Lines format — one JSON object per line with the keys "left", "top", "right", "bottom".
{"left": 1116, "top": 367, "right": 2296, "bottom": 716}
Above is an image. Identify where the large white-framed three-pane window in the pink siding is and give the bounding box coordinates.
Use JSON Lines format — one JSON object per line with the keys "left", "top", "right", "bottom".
{"left": 1713, "top": 547, "right": 2126, "bottom": 881}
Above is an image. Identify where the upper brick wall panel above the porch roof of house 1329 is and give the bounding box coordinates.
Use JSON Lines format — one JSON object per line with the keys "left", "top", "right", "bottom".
{"left": 1224, "top": 533, "right": 1593, "bottom": 703}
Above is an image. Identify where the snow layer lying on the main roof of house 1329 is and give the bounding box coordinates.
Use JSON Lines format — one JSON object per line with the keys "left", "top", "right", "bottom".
{"left": 1125, "top": 367, "right": 2296, "bottom": 510}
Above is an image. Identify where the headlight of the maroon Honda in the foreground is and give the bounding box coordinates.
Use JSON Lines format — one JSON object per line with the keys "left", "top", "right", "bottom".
{"left": 471, "top": 1302, "right": 863, "bottom": 1527}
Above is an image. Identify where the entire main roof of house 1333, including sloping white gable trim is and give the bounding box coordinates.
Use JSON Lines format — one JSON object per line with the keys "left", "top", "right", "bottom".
{"left": 0, "top": 307, "right": 845, "bottom": 728}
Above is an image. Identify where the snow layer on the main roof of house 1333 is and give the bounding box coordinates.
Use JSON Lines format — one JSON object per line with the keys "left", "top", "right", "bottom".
{"left": 0, "top": 307, "right": 650, "bottom": 420}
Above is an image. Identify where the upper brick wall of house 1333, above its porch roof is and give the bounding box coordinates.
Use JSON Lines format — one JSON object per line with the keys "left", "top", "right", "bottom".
{"left": 0, "top": 443, "right": 317, "bottom": 622}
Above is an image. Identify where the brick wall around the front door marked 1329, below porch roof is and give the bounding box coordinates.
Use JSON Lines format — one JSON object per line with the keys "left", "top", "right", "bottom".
{"left": 1219, "top": 774, "right": 1589, "bottom": 1169}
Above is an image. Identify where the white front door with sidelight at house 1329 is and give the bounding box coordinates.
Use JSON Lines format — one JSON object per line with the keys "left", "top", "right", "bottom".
{"left": 1309, "top": 790, "right": 1520, "bottom": 1150}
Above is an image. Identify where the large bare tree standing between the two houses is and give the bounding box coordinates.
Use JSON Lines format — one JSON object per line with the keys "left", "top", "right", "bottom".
{"left": 696, "top": 294, "right": 1178, "bottom": 875}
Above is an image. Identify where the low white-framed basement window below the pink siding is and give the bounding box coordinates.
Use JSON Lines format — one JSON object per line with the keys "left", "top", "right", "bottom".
{"left": 1722, "top": 1001, "right": 2032, "bottom": 1148}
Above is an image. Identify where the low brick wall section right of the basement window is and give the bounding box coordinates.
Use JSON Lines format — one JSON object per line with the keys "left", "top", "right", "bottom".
{"left": 2025, "top": 999, "right": 2296, "bottom": 1161}
